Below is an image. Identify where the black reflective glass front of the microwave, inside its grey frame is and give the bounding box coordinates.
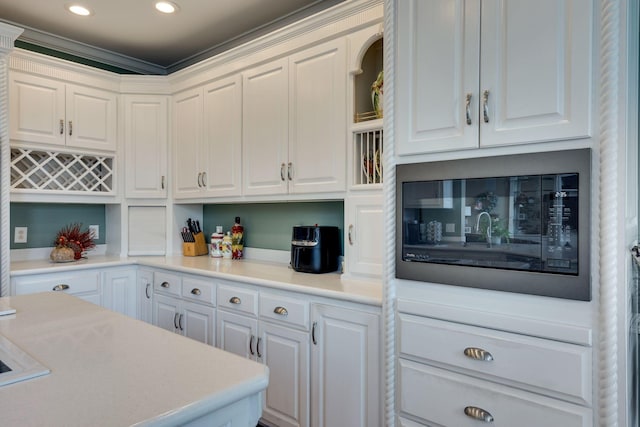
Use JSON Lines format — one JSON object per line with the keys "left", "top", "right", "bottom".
{"left": 401, "top": 173, "right": 579, "bottom": 275}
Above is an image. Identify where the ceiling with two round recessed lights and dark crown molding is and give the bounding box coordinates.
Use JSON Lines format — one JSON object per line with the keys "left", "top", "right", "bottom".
{"left": 0, "top": 0, "right": 344, "bottom": 74}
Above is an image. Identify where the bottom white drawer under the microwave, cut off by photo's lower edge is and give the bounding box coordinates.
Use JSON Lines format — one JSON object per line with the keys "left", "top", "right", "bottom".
{"left": 399, "top": 359, "right": 592, "bottom": 427}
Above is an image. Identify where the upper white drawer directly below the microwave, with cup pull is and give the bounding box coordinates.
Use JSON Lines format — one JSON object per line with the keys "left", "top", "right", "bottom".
{"left": 398, "top": 314, "right": 592, "bottom": 405}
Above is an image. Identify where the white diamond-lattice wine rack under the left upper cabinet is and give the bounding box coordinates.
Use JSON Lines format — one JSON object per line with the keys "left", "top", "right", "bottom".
{"left": 11, "top": 148, "right": 114, "bottom": 194}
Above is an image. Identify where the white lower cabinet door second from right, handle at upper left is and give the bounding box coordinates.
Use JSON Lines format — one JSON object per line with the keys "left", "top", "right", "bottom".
{"left": 257, "top": 322, "right": 309, "bottom": 427}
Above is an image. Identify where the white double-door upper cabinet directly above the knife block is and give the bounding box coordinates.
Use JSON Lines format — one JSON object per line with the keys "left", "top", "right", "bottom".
{"left": 173, "top": 75, "right": 242, "bottom": 198}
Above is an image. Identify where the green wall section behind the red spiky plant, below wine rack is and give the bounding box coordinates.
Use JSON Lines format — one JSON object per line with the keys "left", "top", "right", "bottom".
{"left": 9, "top": 203, "right": 107, "bottom": 249}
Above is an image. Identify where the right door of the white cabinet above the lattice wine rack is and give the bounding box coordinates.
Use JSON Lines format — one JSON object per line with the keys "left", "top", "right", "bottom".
{"left": 66, "top": 85, "right": 117, "bottom": 151}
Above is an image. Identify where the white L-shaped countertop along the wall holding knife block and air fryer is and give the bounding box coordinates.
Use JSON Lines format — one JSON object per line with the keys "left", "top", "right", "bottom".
{"left": 11, "top": 256, "right": 382, "bottom": 306}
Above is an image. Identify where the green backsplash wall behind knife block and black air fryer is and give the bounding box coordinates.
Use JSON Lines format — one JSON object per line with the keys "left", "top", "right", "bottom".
{"left": 202, "top": 201, "right": 344, "bottom": 251}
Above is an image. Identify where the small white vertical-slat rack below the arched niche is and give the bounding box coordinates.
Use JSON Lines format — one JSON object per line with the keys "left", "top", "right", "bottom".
{"left": 353, "top": 129, "right": 382, "bottom": 185}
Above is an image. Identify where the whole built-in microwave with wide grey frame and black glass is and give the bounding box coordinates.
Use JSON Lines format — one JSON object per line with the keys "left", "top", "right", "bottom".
{"left": 396, "top": 149, "right": 591, "bottom": 301}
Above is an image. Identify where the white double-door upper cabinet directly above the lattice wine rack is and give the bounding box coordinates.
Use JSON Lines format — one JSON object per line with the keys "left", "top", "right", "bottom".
{"left": 9, "top": 71, "right": 117, "bottom": 151}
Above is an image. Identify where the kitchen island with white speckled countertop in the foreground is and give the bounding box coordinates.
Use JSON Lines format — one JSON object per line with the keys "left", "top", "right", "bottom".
{"left": 0, "top": 292, "right": 268, "bottom": 426}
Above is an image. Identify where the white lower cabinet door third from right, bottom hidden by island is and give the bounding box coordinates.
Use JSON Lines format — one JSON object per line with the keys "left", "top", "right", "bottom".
{"left": 218, "top": 310, "right": 258, "bottom": 360}
